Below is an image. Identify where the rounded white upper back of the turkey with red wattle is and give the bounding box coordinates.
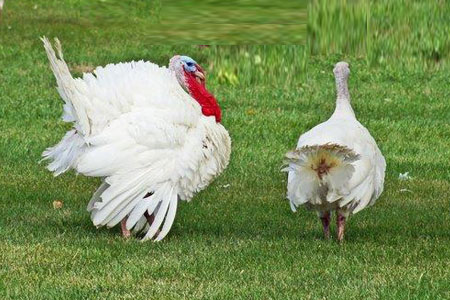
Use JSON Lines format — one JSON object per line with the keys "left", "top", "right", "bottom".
{"left": 75, "top": 61, "right": 201, "bottom": 135}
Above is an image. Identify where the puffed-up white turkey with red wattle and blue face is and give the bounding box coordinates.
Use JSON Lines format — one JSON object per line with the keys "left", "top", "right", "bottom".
{"left": 42, "top": 37, "right": 231, "bottom": 241}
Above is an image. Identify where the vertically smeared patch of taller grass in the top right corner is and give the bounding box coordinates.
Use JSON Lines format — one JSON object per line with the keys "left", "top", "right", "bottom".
{"left": 307, "top": 0, "right": 450, "bottom": 69}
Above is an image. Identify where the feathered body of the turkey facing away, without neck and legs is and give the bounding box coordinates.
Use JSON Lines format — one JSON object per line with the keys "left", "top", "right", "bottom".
{"left": 288, "top": 116, "right": 385, "bottom": 215}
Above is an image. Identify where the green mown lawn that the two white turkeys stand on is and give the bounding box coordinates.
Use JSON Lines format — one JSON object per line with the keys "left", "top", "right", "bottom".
{"left": 0, "top": 0, "right": 450, "bottom": 300}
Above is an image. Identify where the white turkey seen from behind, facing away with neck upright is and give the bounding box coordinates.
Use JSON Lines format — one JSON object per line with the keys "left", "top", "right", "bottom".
{"left": 285, "top": 62, "right": 386, "bottom": 241}
